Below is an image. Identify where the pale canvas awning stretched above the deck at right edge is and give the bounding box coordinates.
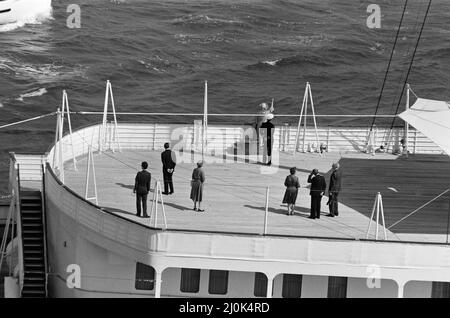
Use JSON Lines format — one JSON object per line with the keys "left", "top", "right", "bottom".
{"left": 399, "top": 98, "right": 450, "bottom": 155}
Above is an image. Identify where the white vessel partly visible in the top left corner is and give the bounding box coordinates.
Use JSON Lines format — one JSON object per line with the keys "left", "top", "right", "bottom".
{"left": 0, "top": 0, "right": 52, "bottom": 25}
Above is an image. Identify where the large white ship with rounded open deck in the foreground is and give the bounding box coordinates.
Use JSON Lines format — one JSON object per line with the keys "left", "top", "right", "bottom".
{"left": 3, "top": 80, "right": 450, "bottom": 298}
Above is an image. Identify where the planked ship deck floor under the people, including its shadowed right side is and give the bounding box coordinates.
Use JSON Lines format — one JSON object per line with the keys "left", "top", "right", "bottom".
{"left": 65, "top": 150, "right": 450, "bottom": 243}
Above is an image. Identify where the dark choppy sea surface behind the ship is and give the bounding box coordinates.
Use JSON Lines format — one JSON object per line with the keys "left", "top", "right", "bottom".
{"left": 0, "top": 0, "right": 450, "bottom": 194}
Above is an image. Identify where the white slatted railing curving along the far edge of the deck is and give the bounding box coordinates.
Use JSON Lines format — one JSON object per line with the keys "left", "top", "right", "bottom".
{"left": 44, "top": 123, "right": 443, "bottom": 171}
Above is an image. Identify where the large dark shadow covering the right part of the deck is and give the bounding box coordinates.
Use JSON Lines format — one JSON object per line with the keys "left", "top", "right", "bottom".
{"left": 338, "top": 155, "right": 450, "bottom": 235}
